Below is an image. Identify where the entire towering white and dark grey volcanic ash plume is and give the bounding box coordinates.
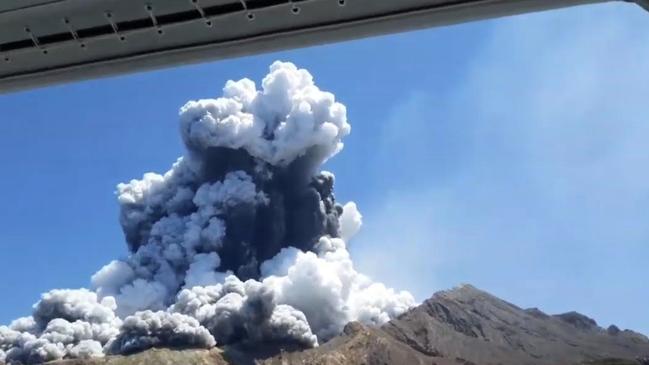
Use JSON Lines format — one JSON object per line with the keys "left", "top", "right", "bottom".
{"left": 0, "top": 62, "right": 414, "bottom": 364}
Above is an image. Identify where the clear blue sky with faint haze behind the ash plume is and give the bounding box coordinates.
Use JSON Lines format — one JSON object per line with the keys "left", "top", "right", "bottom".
{"left": 0, "top": 4, "right": 649, "bottom": 334}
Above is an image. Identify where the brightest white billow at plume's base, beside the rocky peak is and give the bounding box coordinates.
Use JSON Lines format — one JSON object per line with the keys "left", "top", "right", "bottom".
{"left": 263, "top": 237, "right": 415, "bottom": 339}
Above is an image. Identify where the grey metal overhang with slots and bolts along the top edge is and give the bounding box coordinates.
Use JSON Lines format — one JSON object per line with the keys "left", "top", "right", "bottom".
{"left": 0, "top": 0, "right": 644, "bottom": 92}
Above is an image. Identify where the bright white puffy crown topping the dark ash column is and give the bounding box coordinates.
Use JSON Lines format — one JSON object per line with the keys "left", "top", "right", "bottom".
{"left": 180, "top": 62, "right": 351, "bottom": 165}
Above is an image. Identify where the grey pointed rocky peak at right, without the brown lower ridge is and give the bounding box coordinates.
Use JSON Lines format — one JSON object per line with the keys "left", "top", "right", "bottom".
{"left": 383, "top": 285, "right": 649, "bottom": 365}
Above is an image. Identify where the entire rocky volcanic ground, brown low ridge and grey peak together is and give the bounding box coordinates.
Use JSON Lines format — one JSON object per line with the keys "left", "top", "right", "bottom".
{"left": 5, "top": 285, "right": 649, "bottom": 365}
